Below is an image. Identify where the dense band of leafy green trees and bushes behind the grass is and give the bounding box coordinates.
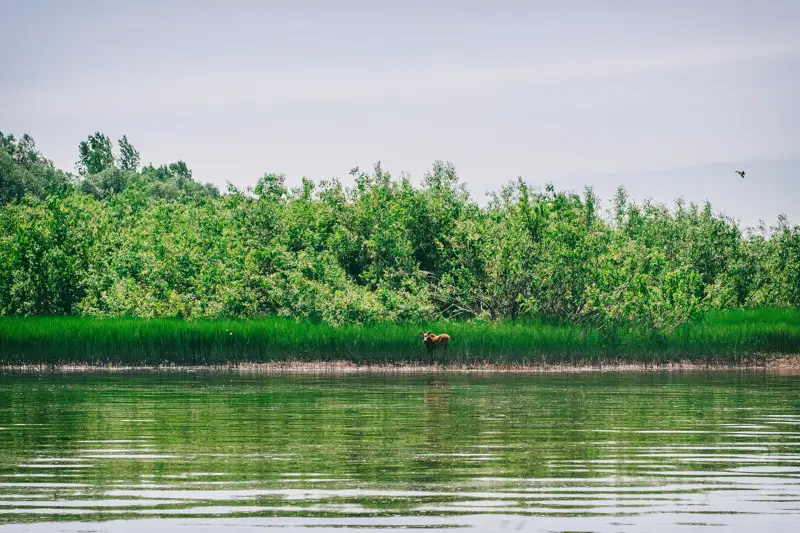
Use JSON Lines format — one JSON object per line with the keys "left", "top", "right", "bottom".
{"left": 0, "top": 132, "right": 800, "bottom": 331}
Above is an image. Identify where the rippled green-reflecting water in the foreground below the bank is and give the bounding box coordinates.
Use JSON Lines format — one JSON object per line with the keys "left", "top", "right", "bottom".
{"left": 0, "top": 373, "right": 800, "bottom": 533}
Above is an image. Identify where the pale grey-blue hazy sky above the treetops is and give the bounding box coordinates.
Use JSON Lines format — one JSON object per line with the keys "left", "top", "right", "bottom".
{"left": 0, "top": 0, "right": 800, "bottom": 226}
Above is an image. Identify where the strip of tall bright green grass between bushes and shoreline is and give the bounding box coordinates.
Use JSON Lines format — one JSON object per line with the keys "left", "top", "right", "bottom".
{"left": 0, "top": 309, "right": 800, "bottom": 365}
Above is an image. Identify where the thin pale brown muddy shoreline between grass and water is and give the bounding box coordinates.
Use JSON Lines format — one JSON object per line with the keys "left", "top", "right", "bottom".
{"left": 0, "top": 354, "right": 800, "bottom": 374}
